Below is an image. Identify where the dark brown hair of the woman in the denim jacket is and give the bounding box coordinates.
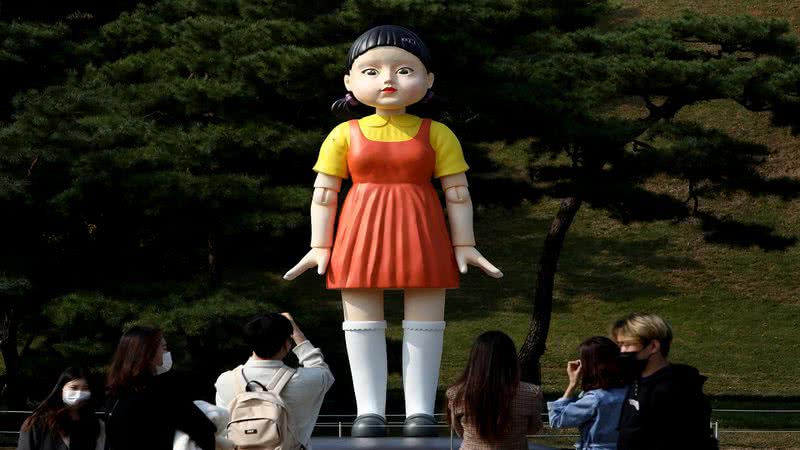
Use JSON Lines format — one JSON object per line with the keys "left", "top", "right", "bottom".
{"left": 580, "top": 336, "right": 625, "bottom": 391}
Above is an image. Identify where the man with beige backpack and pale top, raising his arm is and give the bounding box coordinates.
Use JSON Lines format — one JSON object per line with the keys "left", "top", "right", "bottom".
{"left": 215, "top": 313, "right": 333, "bottom": 450}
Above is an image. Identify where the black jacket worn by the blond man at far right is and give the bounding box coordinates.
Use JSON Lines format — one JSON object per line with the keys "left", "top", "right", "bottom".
{"left": 617, "top": 364, "right": 718, "bottom": 450}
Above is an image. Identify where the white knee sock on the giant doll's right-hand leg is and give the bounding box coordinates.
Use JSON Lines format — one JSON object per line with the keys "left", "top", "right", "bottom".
{"left": 403, "top": 320, "right": 445, "bottom": 417}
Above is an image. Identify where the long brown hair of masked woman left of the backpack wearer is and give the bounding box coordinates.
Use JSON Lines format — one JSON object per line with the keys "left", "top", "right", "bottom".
{"left": 106, "top": 326, "right": 164, "bottom": 397}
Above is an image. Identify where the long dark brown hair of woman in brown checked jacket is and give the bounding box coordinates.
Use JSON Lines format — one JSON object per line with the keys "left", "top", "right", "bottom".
{"left": 446, "top": 331, "right": 520, "bottom": 442}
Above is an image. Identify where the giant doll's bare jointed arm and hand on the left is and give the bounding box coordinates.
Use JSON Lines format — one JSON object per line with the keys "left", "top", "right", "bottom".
{"left": 283, "top": 173, "right": 342, "bottom": 280}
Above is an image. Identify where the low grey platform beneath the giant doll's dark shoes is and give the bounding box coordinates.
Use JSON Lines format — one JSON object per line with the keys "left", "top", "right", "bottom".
{"left": 311, "top": 437, "right": 555, "bottom": 450}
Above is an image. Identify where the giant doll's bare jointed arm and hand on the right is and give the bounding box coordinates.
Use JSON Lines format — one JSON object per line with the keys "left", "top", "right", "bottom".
{"left": 441, "top": 172, "right": 503, "bottom": 278}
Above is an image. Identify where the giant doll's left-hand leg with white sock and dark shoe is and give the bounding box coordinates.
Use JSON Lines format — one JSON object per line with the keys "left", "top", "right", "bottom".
{"left": 342, "top": 289, "right": 387, "bottom": 437}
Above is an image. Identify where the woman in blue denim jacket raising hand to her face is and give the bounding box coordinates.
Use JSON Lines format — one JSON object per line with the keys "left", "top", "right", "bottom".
{"left": 547, "top": 336, "right": 628, "bottom": 450}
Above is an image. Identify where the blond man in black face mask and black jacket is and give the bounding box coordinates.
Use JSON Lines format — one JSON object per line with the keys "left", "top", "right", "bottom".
{"left": 610, "top": 313, "right": 719, "bottom": 450}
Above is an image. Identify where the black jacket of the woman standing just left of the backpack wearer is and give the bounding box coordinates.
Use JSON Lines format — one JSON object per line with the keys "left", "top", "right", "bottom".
{"left": 106, "top": 373, "right": 216, "bottom": 450}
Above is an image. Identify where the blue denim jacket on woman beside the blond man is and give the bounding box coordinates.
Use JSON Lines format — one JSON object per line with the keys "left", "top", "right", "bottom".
{"left": 547, "top": 387, "right": 627, "bottom": 450}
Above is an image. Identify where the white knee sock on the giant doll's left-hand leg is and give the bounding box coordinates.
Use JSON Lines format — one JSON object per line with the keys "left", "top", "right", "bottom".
{"left": 342, "top": 320, "right": 387, "bottom": 417}
